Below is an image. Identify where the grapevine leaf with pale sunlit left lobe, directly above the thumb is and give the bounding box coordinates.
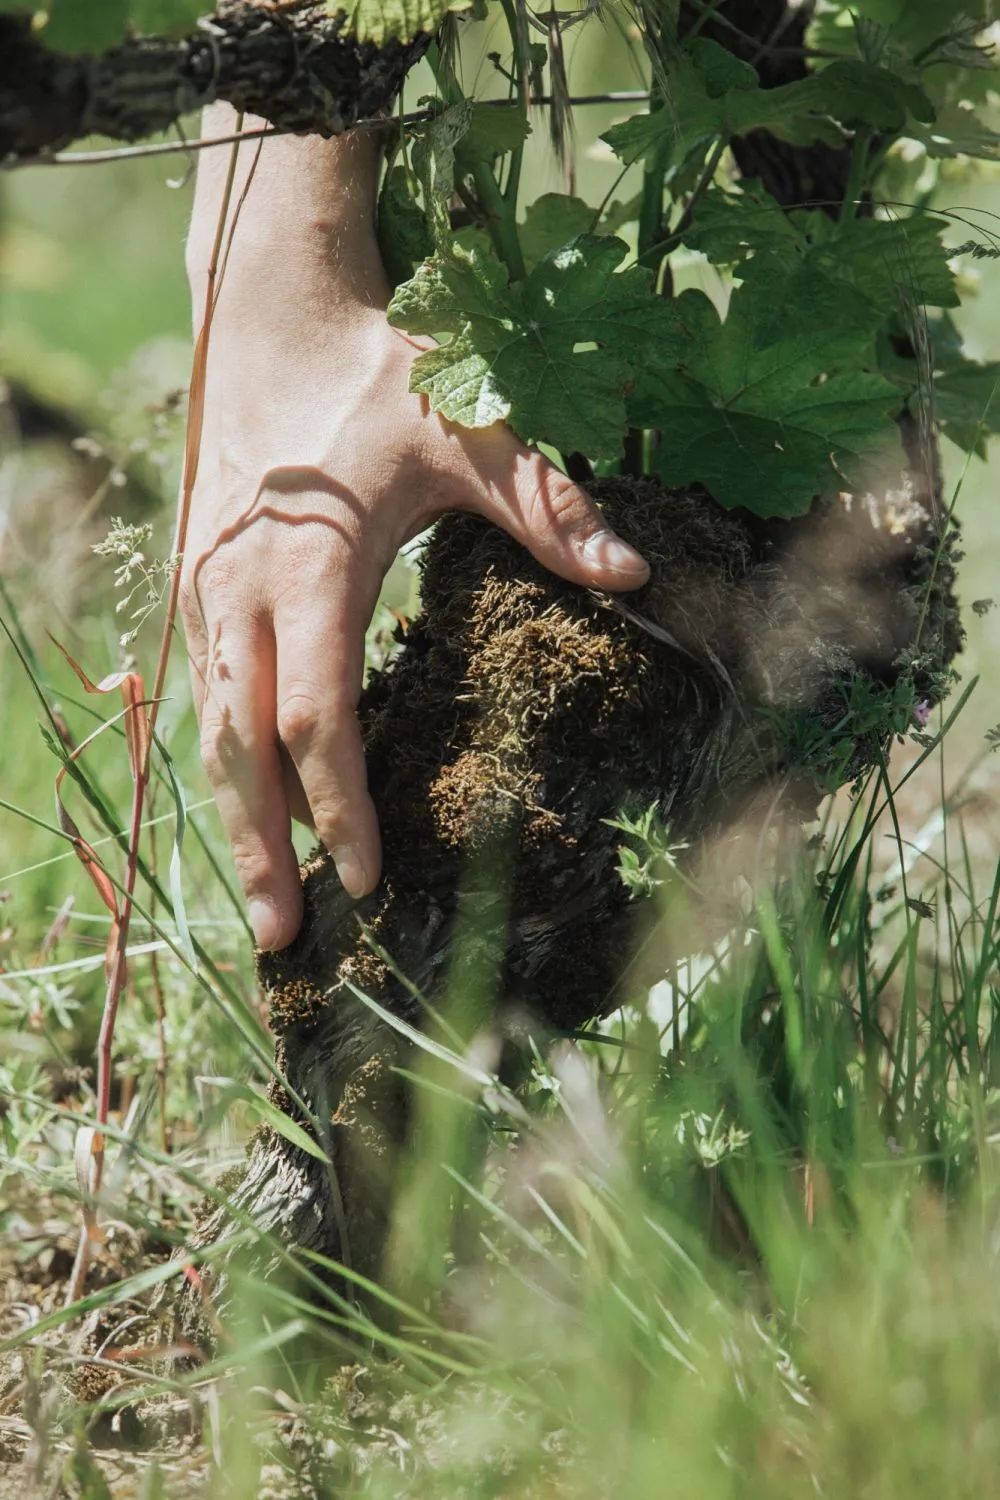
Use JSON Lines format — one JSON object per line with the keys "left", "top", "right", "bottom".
{"left": 388, "top": 234, "right": 673, "bottom": 458}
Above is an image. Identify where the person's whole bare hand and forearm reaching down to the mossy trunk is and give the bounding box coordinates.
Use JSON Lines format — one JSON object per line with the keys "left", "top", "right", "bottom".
{"left": 181, "top": 105, "right": 648, "bottom": 950}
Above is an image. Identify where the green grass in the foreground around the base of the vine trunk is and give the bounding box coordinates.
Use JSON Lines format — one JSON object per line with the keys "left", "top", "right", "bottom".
{"left": 0, "top": 612, "right": 1000, "bottom": 1500}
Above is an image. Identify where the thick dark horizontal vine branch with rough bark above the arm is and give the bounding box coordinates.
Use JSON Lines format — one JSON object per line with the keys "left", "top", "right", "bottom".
{"left": 0, "top": 0, "right": 429, "bottom": 159}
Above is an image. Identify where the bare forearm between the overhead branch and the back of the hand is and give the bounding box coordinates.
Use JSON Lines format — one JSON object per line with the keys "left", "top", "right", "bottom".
{"left": 187, "top": 105, "right": 387, "bottom": 336}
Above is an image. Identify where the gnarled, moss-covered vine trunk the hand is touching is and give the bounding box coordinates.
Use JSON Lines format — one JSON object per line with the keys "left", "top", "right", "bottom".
{"left": 179, "top": 0, "right": 960, "bottom": 1274}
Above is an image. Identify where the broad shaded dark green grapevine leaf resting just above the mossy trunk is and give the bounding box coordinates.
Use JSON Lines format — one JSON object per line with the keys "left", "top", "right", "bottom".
{"left": 630, "top": 272, "right": 900, "bottom": 516}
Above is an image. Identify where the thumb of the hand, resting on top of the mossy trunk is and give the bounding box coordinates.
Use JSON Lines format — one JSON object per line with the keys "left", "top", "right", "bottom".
{"left": 455, "top": 449, "right": 649, "bottom": 590}
